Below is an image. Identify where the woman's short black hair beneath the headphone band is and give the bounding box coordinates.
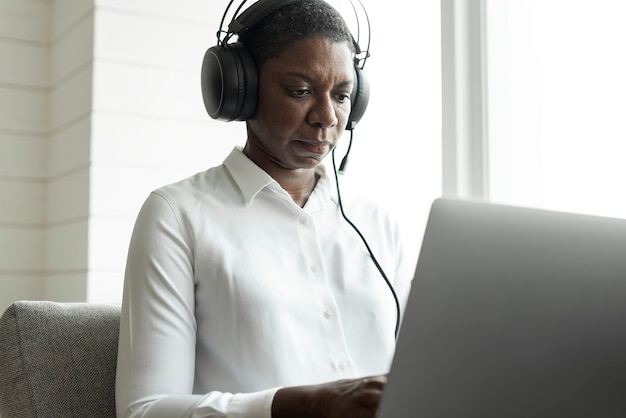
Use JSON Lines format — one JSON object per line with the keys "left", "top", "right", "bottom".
{"left": 239, "top": 0, "right": 356, "bottom": 70}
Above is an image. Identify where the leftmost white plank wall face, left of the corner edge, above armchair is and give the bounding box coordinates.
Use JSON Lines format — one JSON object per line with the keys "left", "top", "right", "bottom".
{"left": 0, "top": 0, "right": 50, "bottom": 308}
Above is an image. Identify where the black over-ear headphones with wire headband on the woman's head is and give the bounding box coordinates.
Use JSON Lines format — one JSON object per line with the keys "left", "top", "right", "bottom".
{"left": 201, "top": 0, "right": 370, "bottom": 130}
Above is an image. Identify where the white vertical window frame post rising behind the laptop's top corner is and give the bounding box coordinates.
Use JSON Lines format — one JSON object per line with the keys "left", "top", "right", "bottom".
{"left": 441, "top": 0, "right": 489, "bottom": 200}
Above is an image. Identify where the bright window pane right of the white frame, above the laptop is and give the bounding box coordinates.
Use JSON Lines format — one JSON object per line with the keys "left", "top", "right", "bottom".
{"left": 486, "top": 0, "right": 626, "bottom": 218}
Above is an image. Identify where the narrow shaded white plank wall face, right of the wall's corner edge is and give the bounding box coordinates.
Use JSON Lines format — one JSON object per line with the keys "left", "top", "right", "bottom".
{"left": 41, "top": 0, "right": 94, "bottom": 301}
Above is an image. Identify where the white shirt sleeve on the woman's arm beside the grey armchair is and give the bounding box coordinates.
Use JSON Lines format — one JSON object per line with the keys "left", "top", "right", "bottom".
{"left": 116, "top": 194, "right": 275, "bottom": 417}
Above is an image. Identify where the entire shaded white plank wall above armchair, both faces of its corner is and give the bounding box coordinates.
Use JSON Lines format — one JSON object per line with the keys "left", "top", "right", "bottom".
{"left": 0, "top": 0, "right": 102, "bottom": 307}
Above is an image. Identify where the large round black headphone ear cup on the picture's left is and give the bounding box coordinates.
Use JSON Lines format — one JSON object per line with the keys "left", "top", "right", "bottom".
{"left": 201, "top": 42, "right": 258, "bottom": 121}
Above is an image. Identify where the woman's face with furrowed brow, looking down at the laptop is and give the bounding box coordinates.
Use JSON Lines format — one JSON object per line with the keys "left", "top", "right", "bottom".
{"left": 245, "top": 37, "right": 354, "bottom": 171}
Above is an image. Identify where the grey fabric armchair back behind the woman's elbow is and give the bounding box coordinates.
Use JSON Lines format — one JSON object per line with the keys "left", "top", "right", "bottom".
{"left": 0, "top": 301, "right": 120, "bottom": 418}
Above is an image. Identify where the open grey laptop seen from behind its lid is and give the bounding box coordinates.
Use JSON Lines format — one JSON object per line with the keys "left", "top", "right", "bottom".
{"left": 378, "top": 199, "right": 626, "bottom": 418}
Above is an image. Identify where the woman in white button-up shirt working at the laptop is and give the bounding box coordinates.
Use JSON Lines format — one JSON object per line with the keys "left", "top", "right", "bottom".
{"left": 116, "top": 0, "right": 414, "bottom": 418}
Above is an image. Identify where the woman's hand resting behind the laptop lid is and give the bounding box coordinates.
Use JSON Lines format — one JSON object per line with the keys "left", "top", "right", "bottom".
{"left": 272, "top": 376, "right": 387, "bottom": 418}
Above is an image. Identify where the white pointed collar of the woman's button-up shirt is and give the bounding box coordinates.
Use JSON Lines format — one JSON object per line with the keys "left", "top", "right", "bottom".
{"left": 224, "top": 147, "right": 332, "bottom": 205}
